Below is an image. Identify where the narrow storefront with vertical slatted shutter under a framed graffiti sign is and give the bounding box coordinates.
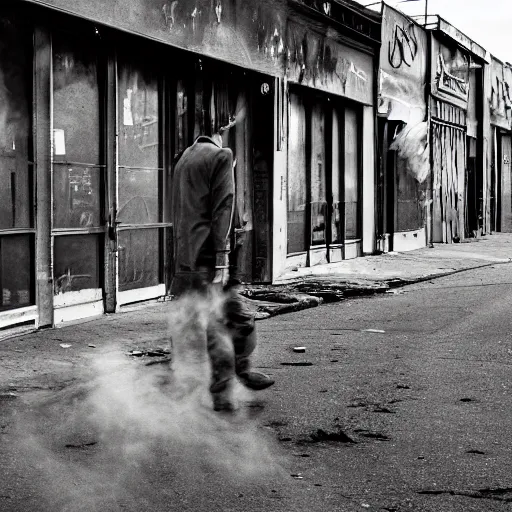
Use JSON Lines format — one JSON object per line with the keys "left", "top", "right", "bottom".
{"left": 429, "top": 17, "right": 486, "bottom": 243}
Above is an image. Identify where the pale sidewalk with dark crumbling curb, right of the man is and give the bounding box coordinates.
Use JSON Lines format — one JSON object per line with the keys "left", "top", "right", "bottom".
{"left": 244, "top": 233, "right": 512, "bottom": 315}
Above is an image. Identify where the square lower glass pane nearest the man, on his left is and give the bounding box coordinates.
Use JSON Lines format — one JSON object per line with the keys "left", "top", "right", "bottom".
{"left": 118, "top": 229, "right": 160, "bottom": 291}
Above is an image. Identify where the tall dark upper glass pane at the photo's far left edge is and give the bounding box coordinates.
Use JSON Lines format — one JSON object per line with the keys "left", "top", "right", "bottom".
{"left": 0, "top": 16, "right": 32, "bottom": 229}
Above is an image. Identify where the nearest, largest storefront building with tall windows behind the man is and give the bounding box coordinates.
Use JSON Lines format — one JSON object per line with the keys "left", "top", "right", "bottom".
{"left": 0, "top": 0, "right": 379, "bottom": 328}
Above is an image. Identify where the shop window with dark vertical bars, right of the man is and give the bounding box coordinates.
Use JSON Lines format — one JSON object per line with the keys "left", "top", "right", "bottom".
{"left": 287, "top": 92, "right": 361, "bottom": 259}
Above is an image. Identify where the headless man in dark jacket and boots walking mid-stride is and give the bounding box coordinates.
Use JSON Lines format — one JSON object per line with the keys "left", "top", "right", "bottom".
{"left": 171, "top": 128, "right": 274, "bottom": 411}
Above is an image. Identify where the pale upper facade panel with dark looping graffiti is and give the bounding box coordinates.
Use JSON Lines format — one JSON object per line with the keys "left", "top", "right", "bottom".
{"left": 379, "top": 4, "right": 427, "bottom": 124}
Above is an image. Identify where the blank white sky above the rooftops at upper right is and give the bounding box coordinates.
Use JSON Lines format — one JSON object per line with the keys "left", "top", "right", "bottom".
{"left": 357, "top": 0, "right": 512, "bottom": 62}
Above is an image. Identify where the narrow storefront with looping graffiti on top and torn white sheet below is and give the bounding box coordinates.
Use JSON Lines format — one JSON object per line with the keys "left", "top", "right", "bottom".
{"left": 377, "top": 4, "right": 431, "bottom": 252}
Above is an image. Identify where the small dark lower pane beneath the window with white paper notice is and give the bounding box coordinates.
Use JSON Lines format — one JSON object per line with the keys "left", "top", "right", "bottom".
{"left": 53, "top": 235, "right": 102, "bottom": 294}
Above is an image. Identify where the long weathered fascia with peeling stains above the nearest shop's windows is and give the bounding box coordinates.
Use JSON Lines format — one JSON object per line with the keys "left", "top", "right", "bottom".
{"left": 25, "top": 0, "right": 373, "bottom": 104}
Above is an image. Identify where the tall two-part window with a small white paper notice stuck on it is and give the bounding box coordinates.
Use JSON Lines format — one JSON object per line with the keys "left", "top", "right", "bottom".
{"left": 52, "top": 33, "right": 105, "bottom": 294}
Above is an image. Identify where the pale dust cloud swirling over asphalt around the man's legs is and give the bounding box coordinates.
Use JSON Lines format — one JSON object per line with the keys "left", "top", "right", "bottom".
{"left": 17, "top": 290, "right": 287, "bottom": 512}
